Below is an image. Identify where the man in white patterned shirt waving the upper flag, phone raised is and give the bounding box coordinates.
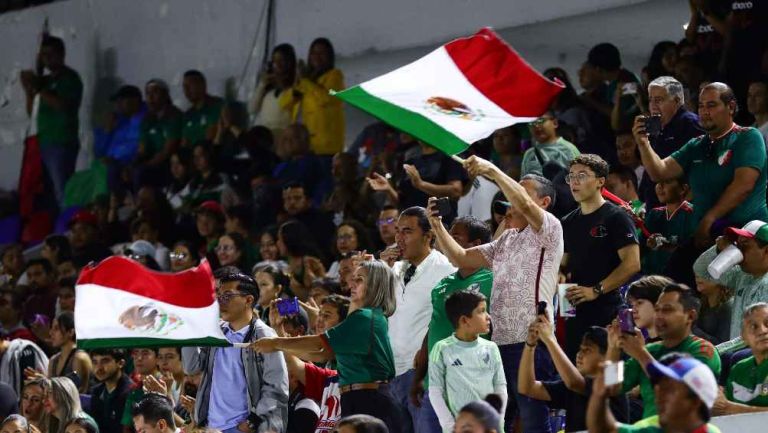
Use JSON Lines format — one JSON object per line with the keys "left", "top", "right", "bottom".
{"left": 430, "top": 156, "right": 563, "bottom": 433}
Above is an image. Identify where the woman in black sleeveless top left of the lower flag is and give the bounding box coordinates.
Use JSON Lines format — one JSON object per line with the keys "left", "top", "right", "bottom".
{"left": 48, "top": 311, "right": 93, "bottom": 393}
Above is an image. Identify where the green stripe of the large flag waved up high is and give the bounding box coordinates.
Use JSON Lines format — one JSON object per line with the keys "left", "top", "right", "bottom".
{"left": 332, "top": 86, "right": 469, "bottom": 155}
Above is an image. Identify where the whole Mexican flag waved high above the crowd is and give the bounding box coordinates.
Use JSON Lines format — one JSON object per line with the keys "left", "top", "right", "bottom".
{"left": 334, "top": 28, "right": 564, "bottom": 155}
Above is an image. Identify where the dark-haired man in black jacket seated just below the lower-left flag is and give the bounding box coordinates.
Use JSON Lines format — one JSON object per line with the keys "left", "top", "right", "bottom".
{"left": 89, "top": 349, "right": 132, "bottom": 433}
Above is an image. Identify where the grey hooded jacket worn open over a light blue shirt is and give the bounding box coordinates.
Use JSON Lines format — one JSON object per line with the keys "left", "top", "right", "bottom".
{"left": 181, "top": 317, "right": 288, "bottom": 433}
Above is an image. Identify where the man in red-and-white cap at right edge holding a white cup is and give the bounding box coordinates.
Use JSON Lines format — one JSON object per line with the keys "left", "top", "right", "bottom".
{"left": 694, "top": 220, "right": 768, "bottom": 339}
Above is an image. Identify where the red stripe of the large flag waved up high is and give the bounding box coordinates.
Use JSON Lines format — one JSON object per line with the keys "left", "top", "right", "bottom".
{"left": 445, "top": 28, "right": 564, "bottom": 117}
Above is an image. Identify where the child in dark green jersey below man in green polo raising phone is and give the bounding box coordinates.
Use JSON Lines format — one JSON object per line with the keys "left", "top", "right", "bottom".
{"left": 642, "top": 178, "right": 696, "bottom": 275}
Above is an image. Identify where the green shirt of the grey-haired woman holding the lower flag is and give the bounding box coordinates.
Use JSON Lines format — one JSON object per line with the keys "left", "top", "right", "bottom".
{"left": 325, "top": 308, "right": 395, "bottom": 386}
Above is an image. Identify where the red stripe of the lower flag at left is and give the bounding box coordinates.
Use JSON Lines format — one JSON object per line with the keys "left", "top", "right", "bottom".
{"left": 77, "top": 256, "right": 216, "bottom": 308}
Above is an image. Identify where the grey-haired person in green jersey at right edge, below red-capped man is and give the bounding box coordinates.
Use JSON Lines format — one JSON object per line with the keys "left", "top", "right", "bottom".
{"left": 714, "top": 302, "right": 768, "bottom": 415}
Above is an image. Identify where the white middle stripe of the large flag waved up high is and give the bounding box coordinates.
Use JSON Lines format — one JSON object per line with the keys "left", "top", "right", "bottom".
{"left": 360, "top": 47, "right": 535, "bottom": 143}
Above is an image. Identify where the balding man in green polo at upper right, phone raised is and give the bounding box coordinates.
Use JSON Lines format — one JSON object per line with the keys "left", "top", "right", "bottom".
{"left": 633, "top": 83, "right": 768, "bottom": 246}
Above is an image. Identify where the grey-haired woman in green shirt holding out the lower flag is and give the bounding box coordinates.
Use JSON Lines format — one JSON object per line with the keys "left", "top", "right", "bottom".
{"left": 251, "top": 260, "right": 400, "bottom": 433}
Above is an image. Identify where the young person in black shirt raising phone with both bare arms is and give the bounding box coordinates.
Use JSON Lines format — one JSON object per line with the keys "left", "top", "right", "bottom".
{"left": 517, "top": 315, "right": 628, "bottom": 432}
